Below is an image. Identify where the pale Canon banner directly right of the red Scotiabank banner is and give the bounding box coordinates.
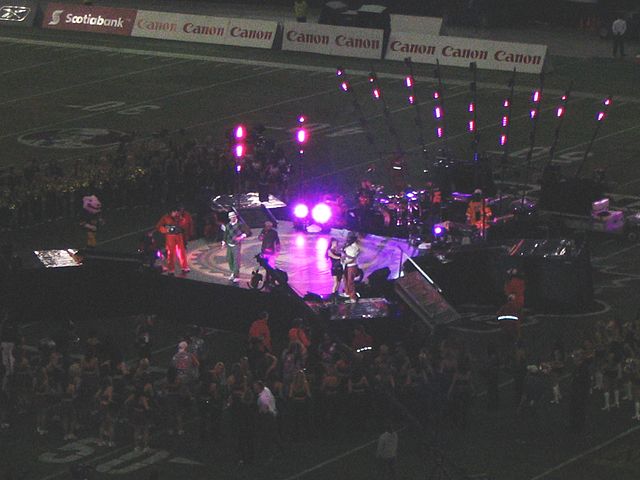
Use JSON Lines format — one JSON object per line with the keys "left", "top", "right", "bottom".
{"left": 131, "top": 10, "right": 278, "bottom": 48}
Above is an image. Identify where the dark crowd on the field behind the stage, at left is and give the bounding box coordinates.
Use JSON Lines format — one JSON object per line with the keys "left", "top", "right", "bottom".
{"left": 0, "top": 126, "right": 291, "bottom": 229}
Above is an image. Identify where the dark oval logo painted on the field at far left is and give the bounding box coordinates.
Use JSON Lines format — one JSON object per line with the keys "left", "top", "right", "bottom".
{"left": 18, "top": 128, "right": 127, "bottom": 149}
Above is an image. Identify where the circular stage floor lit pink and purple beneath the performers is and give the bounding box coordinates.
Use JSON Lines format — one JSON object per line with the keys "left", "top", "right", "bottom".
{"left": 183, "top": 222, "right": 417, "bottom": 297}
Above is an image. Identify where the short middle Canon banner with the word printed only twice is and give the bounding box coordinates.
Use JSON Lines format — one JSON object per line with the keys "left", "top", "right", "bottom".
{"left": 282, "top": 22, "right": 383, "bottom": 58}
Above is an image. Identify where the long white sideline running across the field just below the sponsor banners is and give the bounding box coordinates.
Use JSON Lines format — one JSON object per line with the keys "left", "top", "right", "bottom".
{"left": 0, "top": 37, "right": 640, "bottom": 104}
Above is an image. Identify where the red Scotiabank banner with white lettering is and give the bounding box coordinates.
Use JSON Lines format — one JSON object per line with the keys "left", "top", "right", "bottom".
{"left": 42, "top": 3, "right": 137, "bottom": 35}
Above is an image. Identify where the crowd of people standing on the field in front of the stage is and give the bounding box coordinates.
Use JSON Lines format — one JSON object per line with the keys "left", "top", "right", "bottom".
{"left": 0, "top": 313, "right": 640, "bottom": 463}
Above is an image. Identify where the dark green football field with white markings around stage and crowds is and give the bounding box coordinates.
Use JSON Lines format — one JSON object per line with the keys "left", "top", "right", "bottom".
{"left": 0, "top": 28, "right": 640, "bottom": 480}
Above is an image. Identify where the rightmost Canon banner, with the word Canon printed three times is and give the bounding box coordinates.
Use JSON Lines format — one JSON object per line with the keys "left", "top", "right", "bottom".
{"left": 385, "top": 32, "right": 547, "bottom": 73}
